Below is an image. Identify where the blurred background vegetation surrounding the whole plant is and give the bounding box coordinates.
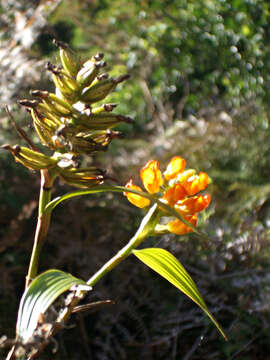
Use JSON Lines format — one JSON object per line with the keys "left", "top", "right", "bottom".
{"left": 0, "top": 0, "right": 270, "bottom": 360}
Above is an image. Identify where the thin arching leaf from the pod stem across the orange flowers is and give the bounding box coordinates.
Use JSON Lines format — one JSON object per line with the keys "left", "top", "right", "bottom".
{"left": 44, "top": 185, "right": 200, "bottom": 233}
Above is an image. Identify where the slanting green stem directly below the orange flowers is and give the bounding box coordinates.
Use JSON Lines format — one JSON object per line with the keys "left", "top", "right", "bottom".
{"left": 87, "top": 204, "right": 160, "bottom": 286}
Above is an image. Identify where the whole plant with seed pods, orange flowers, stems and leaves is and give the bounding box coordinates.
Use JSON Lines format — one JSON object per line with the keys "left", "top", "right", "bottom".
{"left": 3, "top": 42, "right": 225, "bottom": 360}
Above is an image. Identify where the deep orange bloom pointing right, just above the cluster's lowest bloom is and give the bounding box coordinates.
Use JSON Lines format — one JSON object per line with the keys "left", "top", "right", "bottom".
{"left": 175, "top": 194, "right": 211, "bottom": 215}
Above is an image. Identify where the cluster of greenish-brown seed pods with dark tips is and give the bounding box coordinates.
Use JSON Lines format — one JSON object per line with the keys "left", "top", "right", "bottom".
{"left": 2, "top": 41, "right": 132, "bottom": 188}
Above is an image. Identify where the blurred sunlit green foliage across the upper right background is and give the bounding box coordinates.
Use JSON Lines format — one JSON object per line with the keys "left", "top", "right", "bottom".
{"left": 49, "top": 0, "right": 269, "bottom": 116}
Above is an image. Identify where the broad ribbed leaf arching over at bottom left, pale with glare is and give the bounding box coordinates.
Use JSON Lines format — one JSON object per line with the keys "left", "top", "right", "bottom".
{"left": 16, "top": 269, "right": 91, "bottom": 342}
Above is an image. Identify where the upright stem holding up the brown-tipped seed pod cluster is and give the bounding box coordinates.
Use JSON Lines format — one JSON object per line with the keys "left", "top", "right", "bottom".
{"left": 25, "top": 169, "right": 54, "bottom": 288}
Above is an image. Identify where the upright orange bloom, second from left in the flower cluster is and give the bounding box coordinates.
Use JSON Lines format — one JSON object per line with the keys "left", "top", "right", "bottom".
{"left": 140, "top": 160, "right": 163, "bottom": 194}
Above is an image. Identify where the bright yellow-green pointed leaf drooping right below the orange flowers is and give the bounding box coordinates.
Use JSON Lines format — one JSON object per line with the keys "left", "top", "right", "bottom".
{"left": 132, "top": 248, "right": 227, "bottom": 339}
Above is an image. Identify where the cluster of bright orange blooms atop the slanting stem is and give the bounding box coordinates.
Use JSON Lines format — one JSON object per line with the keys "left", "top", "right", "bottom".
{"left": 124, "top": 156, "right": 211, "bottom": 235}
